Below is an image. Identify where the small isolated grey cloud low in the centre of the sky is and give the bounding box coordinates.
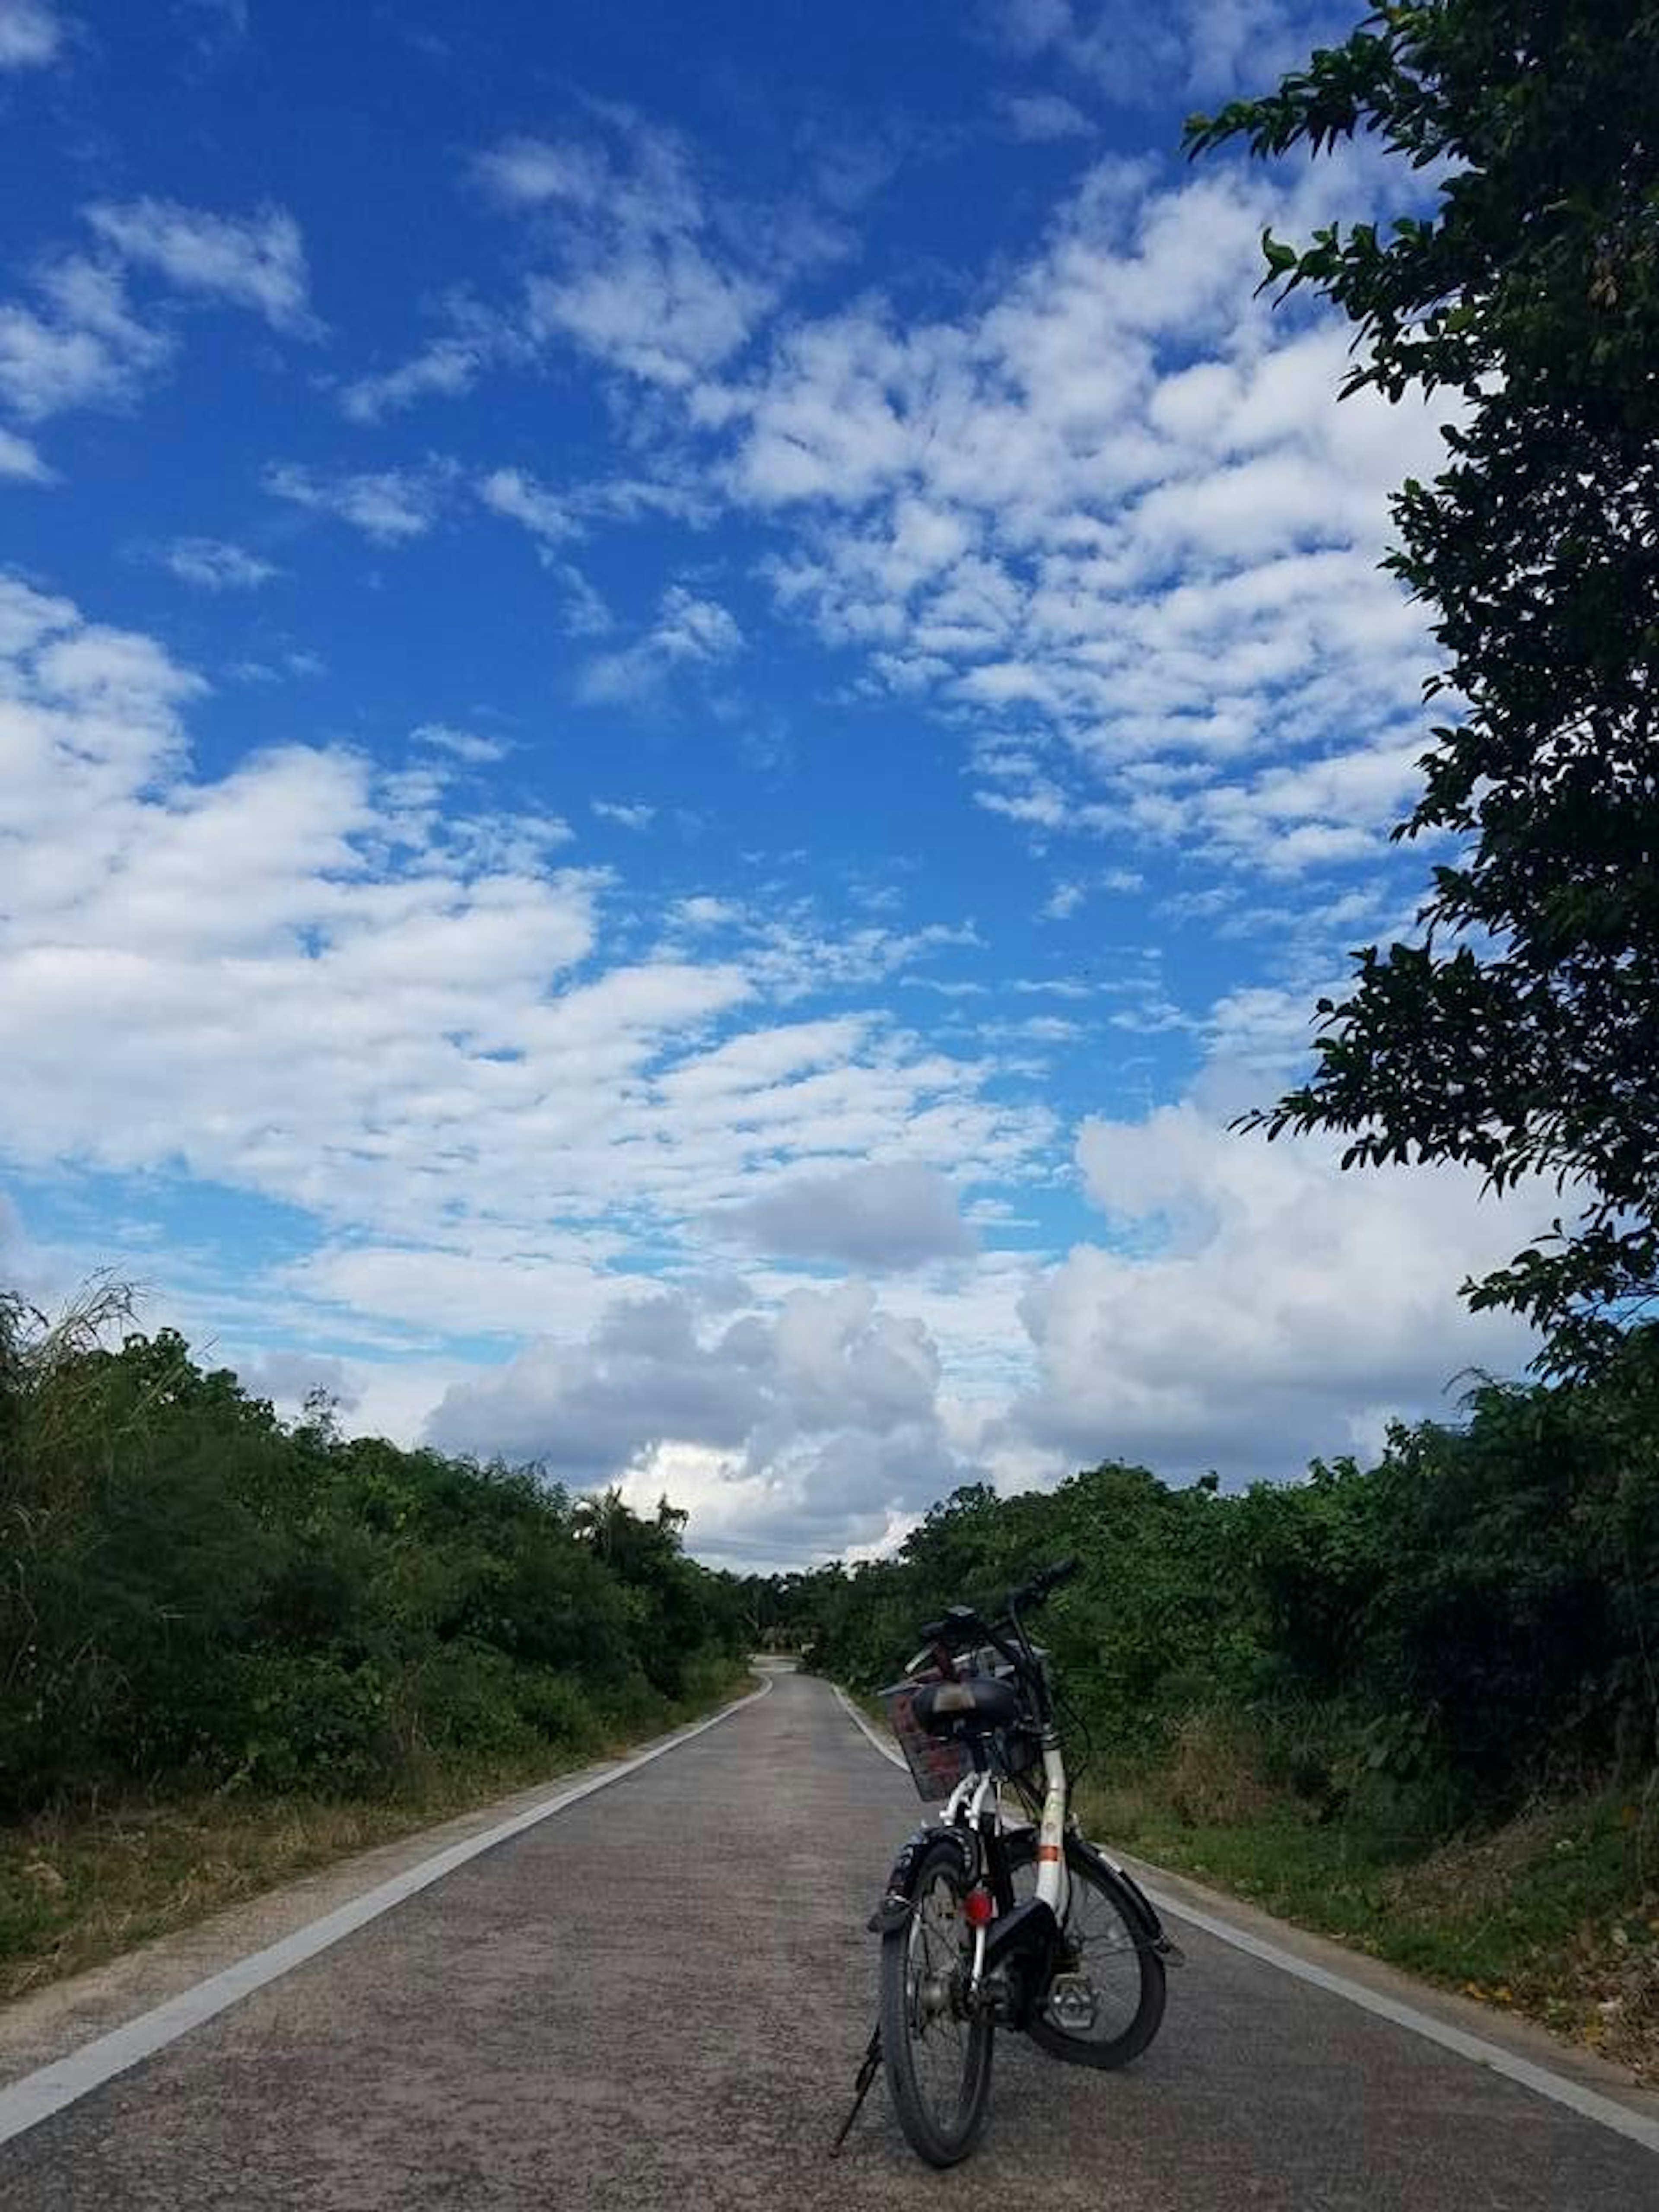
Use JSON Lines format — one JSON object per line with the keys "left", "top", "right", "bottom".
{"left": 717, "top": 1159, "right": 976, "bottom": 1274}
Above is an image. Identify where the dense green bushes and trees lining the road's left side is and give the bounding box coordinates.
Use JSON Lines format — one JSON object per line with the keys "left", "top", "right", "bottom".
{"left": 0, "top": 1292, "right": 748, "bottom": 1816}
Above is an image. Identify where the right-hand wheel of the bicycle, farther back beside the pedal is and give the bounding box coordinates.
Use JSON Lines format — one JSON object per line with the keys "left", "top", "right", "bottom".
{"left": 1007, "top": 1829, "right": 1166, "bottom": 2070}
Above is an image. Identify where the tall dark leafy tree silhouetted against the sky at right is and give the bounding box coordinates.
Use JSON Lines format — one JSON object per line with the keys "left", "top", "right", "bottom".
{"left": 1185, "top": 0, "right": 1659, "bottom": 1371}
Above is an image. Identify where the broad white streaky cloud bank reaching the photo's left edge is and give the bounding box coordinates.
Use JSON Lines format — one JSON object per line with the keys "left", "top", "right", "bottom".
{"left": 0, "top": 584, "right": 1046, "bottom": 1402}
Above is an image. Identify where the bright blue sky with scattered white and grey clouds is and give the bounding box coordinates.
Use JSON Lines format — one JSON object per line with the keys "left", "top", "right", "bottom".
{"left": 0, "top": 0, "right": 1540, "bottom": 1568}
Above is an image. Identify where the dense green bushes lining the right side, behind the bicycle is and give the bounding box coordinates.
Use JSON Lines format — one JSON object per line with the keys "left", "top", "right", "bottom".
{"left": 752, "top": 1329, "right": 1659, "bottom": 1843}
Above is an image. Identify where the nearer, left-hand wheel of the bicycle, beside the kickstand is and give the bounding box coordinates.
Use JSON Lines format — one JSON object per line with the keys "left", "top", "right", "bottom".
{"left": 880, "top": 1840, "right": 993, "bottom": 2165}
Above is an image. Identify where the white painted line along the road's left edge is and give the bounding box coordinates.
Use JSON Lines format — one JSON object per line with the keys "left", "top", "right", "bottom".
{"left": 0, "top": 1679, "right": 772, "bottom": 2143}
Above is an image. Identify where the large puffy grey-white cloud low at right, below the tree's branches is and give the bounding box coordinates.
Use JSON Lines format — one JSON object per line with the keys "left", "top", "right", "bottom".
{"left": 995, "top": 1100, "right": 1548, "bottom": 1480}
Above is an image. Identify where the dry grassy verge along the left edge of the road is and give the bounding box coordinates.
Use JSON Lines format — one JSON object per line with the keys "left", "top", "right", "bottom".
{"left": 0, "top": 1665, "right": 750, "bottom": 2004}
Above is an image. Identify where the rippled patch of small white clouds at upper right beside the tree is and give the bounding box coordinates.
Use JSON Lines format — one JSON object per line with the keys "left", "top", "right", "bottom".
{"left": 668, "top": 153, "right": 1442, "bottom": 915}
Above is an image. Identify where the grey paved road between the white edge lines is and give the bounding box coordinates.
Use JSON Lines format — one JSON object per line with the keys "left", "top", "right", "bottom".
{"left": 0, "top": 1677, "right": 1659, "bottom": 2212}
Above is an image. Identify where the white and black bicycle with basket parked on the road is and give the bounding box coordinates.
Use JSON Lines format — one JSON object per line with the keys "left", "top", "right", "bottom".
{"left": 834, "top": 1560, "right": 1181, "bottom": 2165}
